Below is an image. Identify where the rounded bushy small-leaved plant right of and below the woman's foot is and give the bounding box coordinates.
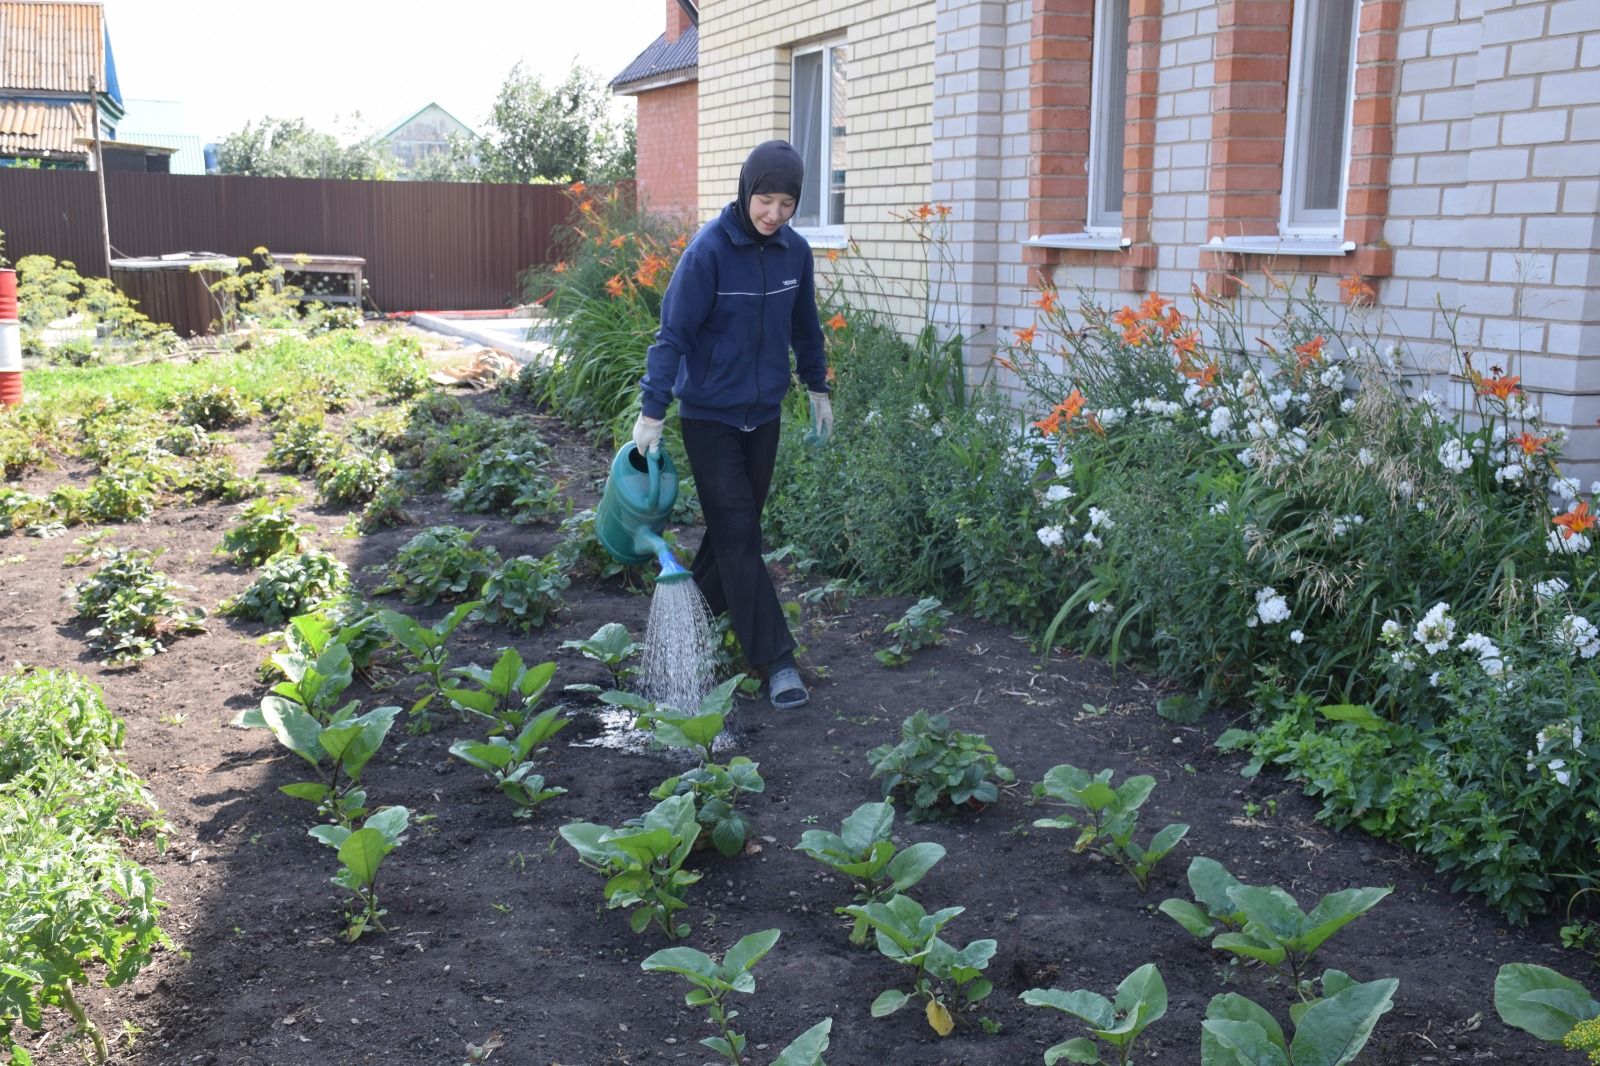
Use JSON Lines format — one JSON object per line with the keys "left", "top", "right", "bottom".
{"left": 867, "top": 711, "right": 1016, "bottom": 821}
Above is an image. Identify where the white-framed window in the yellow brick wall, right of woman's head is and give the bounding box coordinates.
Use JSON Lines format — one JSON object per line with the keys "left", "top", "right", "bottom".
{"left": 789, "top": 45, "right": 850, "bottom": 232}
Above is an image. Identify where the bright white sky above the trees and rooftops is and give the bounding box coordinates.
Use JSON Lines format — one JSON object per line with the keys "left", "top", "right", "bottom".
{"left": 104, "top": 0, "right": 667, "bottom": 141}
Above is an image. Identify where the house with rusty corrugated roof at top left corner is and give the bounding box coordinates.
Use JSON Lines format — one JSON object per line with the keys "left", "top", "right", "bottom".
{"left": 0, "top": 0, "right": 123, "bottom": 170}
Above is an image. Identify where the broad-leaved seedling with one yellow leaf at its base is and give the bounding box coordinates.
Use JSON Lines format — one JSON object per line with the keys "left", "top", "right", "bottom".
{"left": 845, "top": 893, "right": 995, "bottom": 1036}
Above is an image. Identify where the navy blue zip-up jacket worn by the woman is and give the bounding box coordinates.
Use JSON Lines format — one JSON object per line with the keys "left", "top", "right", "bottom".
{"left": 638, "top": 202, "right": 827, "bottom": 427}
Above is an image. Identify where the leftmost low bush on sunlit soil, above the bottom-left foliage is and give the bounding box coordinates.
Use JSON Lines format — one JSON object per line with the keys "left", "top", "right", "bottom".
{"left": 74, "top": 547, "right": 205, "bottom": 663}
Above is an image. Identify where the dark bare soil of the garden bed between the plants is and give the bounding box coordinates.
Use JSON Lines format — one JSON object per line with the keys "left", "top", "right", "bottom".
{"left": 0, "top": 342, "right": 1592, "bottom": 1066}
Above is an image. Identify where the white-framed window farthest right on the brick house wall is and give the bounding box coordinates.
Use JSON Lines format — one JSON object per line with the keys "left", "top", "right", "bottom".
{"left": 1282, "top": 0, "right": 1360, "bottom": 237}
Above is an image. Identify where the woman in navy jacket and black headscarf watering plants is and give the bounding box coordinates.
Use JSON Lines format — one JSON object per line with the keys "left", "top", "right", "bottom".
{"left": 634, "top": 141, "right": 834, "bottom": 709}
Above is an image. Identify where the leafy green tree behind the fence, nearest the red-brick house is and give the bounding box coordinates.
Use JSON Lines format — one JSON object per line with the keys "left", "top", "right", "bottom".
{"left": 480, "top": 62, "right": 635, "bottom": 182}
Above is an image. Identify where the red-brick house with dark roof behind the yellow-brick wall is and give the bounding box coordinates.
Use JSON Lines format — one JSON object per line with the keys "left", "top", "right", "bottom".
{"left": 611, "top": 0, "right": 700, "bottom": 218}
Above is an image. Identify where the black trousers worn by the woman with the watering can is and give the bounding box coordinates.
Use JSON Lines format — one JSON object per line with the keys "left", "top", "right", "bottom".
{"left": 680, "top": 418, "right": 795, "bottom": 667}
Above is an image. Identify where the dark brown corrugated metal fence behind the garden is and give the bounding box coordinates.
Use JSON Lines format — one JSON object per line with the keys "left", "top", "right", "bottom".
{"left": 0, "top": 168, "right": 571, "bottom": 311}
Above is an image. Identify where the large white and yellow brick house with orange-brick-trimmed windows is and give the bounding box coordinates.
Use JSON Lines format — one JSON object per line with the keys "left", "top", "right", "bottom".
{"left": 699, "top": 0, "right": 1600, "bottom": 464}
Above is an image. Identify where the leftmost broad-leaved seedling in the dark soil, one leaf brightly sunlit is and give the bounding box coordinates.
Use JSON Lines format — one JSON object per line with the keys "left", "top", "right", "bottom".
{"left": 261, "top": 699, "right": 400, "bottom": 826}
